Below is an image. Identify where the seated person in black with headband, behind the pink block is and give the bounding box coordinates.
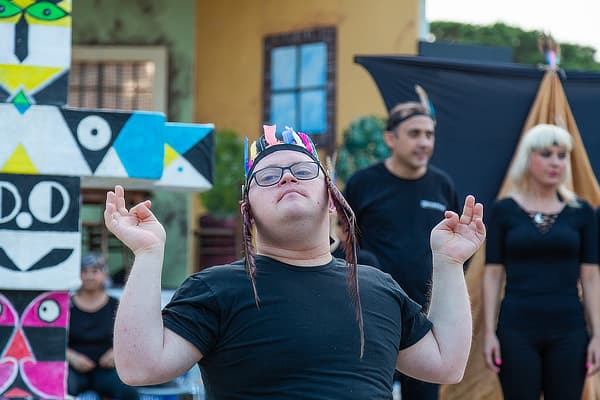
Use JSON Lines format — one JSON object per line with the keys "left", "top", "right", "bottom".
{"left": 67, "top": 253, "right": 138, "bottom": 399}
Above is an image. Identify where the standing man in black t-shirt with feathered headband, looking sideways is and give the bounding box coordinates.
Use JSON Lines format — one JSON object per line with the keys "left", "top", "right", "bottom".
{"left": 345, "top": 86, "right": 459, "bottom": 400}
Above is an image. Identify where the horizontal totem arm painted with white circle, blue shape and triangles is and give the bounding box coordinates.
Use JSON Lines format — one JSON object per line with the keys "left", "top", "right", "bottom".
{"left": 0, "top": 103, "right": 214, "bottom": 191}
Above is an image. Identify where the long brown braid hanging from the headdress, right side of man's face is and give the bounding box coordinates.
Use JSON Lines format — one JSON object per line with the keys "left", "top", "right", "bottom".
{"left": 325, "top": 174, "right": 365, "bottom": 358}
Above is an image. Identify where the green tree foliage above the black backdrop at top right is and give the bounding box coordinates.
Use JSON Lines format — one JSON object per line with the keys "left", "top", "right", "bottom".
{"left": 430, "top": 21, "right": 600, "bottom": 71}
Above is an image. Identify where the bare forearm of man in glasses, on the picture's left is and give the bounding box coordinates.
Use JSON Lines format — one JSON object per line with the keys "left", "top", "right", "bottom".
{"left": 114, "top": 246, "right": 164, "bottom": 380}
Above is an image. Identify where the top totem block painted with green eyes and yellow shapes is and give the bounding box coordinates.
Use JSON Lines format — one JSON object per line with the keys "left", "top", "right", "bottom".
{"left": 0, "top": 0, "right": 71, "bottom": 110}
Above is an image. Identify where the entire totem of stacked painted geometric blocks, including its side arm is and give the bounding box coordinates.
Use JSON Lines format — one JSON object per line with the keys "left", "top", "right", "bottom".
{"left": 0, "top": 0, "right": 214, "bottom": 399}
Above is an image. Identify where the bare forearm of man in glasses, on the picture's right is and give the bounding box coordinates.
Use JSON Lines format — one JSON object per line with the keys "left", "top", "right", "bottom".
{"left": 429, "top": 255, "right": 472, "bottom": 375}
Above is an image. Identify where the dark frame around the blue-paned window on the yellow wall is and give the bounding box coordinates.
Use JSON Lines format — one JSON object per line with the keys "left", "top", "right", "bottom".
{"left": 262, "top": 27, "right": 337, "bottom": 153}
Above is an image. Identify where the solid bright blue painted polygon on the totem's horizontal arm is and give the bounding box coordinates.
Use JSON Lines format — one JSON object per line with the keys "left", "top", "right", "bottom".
{"left": 113, "top": 112, "right": 165, "bottom": 179}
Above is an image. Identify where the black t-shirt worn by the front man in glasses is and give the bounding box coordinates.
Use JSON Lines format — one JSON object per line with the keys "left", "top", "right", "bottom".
{"left": 163, "top": 256, "right": 431, "bottom": 400}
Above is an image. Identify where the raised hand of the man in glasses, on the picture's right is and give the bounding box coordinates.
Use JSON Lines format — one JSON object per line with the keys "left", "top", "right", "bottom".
{"left": 431, "top": 195, "right": 485, "bottom": 264}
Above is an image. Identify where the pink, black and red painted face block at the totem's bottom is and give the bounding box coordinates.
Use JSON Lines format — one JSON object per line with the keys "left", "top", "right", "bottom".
{"left": 0, "top": 291, "right": 69, "bottom": 399}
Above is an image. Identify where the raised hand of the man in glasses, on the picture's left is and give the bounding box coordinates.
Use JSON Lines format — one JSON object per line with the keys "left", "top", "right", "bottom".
{"left": 104, "top": 185, "right": 166, "bottom": 254}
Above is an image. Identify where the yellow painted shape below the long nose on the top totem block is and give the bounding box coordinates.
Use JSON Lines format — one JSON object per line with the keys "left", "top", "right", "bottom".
{"left": 0, "top": 64, "right": 67, "bottom": 92}
